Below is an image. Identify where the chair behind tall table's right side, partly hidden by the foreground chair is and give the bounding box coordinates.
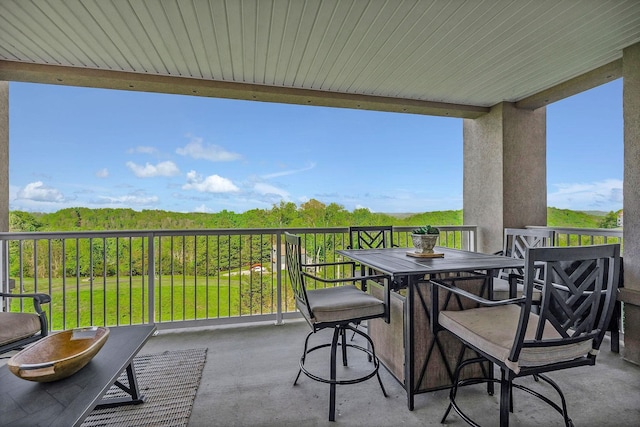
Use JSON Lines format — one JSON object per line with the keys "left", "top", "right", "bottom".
{"left": 492, "top": 228, "right": 555, "bottom": 301}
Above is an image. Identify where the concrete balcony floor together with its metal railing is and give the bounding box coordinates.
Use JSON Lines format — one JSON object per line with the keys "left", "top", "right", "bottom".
{"left": 0, "top": 226, "right": 640, "bottom": 426}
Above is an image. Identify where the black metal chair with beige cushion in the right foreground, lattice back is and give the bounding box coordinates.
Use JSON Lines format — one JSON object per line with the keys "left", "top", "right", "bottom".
{"left": 431, "top": 244, "right": 620, "bottom": 426}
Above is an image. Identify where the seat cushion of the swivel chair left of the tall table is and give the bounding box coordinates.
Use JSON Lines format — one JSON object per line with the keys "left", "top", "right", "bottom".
{"left": 307, "top": 285, "right": 384, "bottom": 323}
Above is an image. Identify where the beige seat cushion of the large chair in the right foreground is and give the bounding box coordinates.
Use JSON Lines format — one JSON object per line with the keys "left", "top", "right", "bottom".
{"left": 438, "top": 304, "right": 593, "bottom": 374}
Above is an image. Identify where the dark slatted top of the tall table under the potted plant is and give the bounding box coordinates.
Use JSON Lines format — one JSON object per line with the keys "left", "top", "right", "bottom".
{"left": 336, "top": 246, "right": 524, "bottom": 278}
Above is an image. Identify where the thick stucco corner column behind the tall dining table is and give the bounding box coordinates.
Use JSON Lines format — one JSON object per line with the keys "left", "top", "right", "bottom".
{"left": 463, "top": 102, "right": 547, "bottom": 253}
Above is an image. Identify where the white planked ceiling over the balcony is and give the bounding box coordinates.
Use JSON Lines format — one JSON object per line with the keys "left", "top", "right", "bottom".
{"left": 0, "top": 0, "right": 640, "bottom": 114}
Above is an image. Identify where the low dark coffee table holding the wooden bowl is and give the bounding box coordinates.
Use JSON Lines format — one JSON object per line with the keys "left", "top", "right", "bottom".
{"left": 0, "top": 325, "right": 156, "bottom": 427}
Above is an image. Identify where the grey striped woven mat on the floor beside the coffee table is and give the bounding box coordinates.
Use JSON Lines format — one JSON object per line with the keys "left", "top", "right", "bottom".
{"left": 82, "top": 348, "right": 207, "bottom": 427}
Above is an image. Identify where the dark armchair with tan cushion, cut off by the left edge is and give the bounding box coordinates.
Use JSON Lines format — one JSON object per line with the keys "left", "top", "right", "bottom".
{"left": 0, "top": 292, "right": 51, "bottom": 354}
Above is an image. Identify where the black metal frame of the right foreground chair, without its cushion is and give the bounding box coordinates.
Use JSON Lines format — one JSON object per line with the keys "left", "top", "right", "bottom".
{"left": 431, "top": 244, "right": 620, "bottom": 427}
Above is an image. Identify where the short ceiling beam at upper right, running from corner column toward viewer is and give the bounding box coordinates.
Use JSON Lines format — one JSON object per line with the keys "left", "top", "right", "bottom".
{"left": 516, "top": 59, "right": 622, "bottom": 110}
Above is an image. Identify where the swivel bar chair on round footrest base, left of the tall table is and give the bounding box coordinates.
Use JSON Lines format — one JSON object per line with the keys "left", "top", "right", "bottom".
{"left": 285, "top": 233, "right": 389, "bottom": 421}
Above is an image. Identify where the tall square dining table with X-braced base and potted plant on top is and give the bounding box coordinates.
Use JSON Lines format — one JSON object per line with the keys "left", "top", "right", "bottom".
{"left": 336, "top": 247, "right": 524, "bottom": 410}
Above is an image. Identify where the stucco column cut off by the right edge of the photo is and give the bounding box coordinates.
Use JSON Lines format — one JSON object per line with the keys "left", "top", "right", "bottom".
{"left": 620, "top": 43, "right": 640, "bottom": 364}
